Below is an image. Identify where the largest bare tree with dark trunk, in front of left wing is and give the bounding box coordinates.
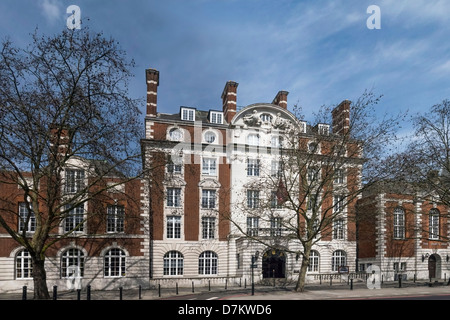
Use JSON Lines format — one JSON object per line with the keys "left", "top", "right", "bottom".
{"left": 0, "top": 27, "right": 141, "bottom": 299}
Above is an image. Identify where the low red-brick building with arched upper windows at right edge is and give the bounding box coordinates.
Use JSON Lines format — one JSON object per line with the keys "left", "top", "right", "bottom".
{"left": 357, "top": 182, "right": 450, "bottom": 281}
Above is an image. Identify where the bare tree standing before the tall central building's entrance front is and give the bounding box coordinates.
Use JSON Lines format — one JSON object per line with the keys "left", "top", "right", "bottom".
{"left": 230, "top": 92, "right": 401, "bottom": 291}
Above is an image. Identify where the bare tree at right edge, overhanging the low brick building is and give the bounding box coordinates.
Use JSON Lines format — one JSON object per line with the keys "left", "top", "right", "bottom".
{"left": 388, "top": 99, "right": 450, "bottom": 241}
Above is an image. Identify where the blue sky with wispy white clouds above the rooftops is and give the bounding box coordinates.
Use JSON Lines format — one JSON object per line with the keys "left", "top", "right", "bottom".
{"left": 0, "top": 0, "right": 450, "bottom": 142}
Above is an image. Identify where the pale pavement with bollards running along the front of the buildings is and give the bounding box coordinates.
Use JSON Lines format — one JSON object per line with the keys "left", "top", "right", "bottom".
{"left": 0, "top": 280, "right": 450, "bottom": 300}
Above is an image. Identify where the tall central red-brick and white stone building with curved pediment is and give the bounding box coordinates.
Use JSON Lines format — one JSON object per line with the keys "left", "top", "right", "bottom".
{"left": 141, "top": 69, "right": 361, "bottom": 285}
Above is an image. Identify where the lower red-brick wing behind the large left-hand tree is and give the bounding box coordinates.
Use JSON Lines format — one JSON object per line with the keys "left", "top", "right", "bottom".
{"left": 0, "top": 157, "right": 148, "bottom": 292}
